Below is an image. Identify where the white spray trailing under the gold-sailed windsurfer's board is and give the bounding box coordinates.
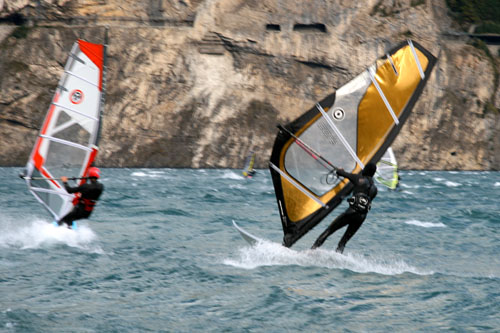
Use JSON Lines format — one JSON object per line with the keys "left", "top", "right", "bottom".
{"left": 223, "top": 241, "right": 434, "bottom": 275}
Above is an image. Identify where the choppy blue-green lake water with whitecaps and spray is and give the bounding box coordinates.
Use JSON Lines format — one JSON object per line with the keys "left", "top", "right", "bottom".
{"left": 0, "top": 168, "right": 500, "bottom": 332}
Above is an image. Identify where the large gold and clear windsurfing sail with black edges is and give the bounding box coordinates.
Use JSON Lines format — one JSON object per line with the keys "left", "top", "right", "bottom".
{"left": 269, "top": 41, "right": 436, "bottom": 247}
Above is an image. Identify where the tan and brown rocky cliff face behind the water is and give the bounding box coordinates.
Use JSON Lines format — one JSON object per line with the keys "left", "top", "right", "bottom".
{"left": 0, "top": 0, "right": 500, "bottom": 170}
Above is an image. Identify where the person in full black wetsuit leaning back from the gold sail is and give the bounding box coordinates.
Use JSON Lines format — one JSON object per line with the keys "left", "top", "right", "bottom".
{"left": 312, "top": 163, "right": 378, "bottom": 253}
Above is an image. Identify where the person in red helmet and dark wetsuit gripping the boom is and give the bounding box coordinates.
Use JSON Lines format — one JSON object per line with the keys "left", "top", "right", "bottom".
{"left": 57, "top": 167, "right": 104, "bottom": 228}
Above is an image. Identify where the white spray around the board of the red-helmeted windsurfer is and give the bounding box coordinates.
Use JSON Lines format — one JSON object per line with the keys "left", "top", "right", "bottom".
{"left": 0, "top": 220, "right": 103, "bottom": 253}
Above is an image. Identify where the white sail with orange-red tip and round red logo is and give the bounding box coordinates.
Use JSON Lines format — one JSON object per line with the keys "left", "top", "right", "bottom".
{"left": 23, "top": 40, "right": 106, "bottom": 220}
